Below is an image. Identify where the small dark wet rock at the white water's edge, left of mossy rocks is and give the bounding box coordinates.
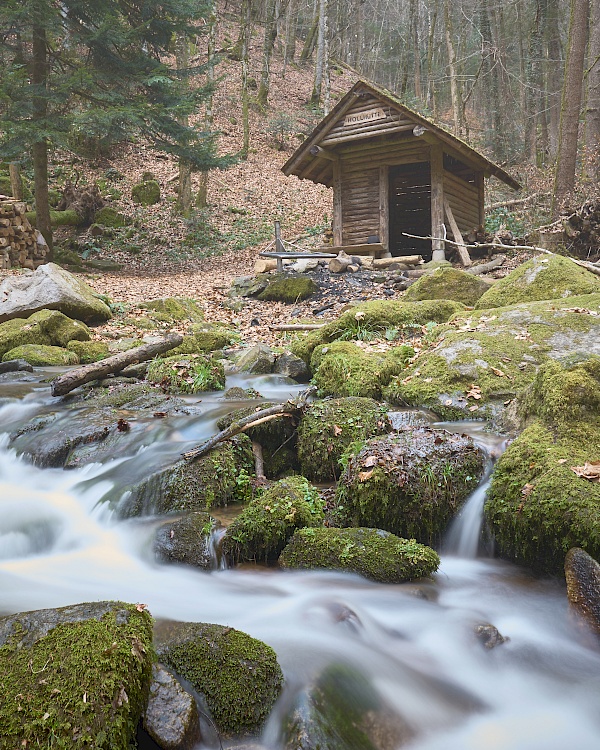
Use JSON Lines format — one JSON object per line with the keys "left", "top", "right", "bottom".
{"left": 153, "top": 512, "right": 221, "bottom": 570}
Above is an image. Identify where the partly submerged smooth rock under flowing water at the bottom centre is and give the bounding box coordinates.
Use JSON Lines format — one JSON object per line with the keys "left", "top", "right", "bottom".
{"left": 281, "top": 664, "right": 413, "bottom": 750}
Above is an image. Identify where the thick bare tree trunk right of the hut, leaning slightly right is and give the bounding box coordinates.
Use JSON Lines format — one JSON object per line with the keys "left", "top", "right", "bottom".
{"left": 552, "top": 0, "right": 590, "bottom": 216}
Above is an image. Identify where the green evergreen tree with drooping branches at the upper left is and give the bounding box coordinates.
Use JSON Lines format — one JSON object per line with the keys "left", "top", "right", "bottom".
{"left": 0, "top": 0, "right": 228, "bottom": 256}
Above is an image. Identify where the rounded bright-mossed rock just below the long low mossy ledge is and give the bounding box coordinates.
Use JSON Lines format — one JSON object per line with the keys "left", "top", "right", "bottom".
{"left": 311, "top": 341, "right": 414, "bottom": 399}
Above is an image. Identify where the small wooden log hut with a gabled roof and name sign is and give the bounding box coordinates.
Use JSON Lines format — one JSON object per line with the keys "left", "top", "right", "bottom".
{"left": 283, "top": 81, "right": 520, "bottom": 260}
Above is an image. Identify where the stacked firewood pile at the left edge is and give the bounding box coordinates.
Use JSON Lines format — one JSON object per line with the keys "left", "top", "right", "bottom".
{"left": 0, "top": 195, "right": 48, "bottom": 271}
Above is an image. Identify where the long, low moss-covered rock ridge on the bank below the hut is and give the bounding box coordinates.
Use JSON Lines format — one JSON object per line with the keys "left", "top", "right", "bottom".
{"left": 290, "top": 300, "right": 464, "bottom": 364}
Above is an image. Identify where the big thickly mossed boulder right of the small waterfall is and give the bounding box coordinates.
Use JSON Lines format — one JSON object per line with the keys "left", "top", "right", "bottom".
{"left": 485, "top": 357, "right": 600, "bottom": 574}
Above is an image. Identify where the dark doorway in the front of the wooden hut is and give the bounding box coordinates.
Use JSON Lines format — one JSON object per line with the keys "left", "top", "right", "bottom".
{"left": 389, "top": 162, "right": 431, "bottom": 259}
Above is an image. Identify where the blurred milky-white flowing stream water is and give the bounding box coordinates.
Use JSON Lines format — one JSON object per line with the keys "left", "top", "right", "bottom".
{"left": 0, "top": 376, "right": 600, "bottom": 750}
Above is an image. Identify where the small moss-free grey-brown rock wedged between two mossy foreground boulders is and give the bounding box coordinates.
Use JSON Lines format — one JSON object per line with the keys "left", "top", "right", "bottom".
{"left": 143, "top": 664, "right": 201, "bottom": 750}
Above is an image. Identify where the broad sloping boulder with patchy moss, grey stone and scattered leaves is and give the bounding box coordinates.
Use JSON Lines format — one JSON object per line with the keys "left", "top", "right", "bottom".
{"left": 383, "top": 294, "right": 600, "bottom": 420}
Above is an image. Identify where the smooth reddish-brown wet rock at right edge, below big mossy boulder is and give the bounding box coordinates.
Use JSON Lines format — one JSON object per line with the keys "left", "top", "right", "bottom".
{"left": 565, "top": 547, "right": 600, "bottom": 636}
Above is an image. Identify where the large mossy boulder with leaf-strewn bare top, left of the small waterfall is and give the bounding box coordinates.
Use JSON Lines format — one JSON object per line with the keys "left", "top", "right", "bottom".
{"left": 333, "top": 427, "right": 484, "bottom": 546}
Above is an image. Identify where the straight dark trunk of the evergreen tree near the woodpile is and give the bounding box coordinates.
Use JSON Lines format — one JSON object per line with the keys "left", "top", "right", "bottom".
{"left": 31, "top": 25, "right": 54, "bottom": 262}
